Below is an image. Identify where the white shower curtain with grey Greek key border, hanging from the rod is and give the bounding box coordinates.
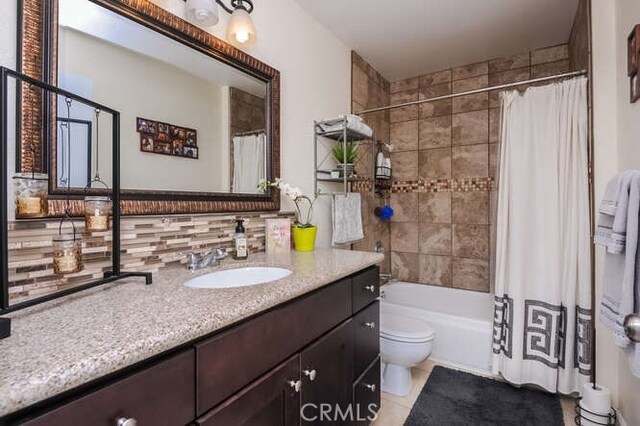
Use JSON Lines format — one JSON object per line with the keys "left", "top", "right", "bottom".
{"left": 493, "top": 77, "right": 592, "bottom": 394}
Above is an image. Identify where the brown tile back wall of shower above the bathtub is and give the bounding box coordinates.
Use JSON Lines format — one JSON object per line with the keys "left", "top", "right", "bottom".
{"left": 389, "top": 44, "right": 569, "bottom": 292}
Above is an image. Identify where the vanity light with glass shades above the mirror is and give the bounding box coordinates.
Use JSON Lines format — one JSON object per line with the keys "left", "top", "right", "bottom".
{"left": 184, "top": 0, "right": 256, "bottom": 47}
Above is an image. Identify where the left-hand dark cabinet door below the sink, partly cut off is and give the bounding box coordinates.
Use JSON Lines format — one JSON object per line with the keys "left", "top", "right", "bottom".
{"left": 195, "top": 355, "right": 301, "bottom": 426}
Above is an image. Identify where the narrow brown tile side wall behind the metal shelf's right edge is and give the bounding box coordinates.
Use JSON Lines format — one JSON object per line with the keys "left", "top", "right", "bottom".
{"left": 351, "top": 52, "right": 391, "bottom": 273}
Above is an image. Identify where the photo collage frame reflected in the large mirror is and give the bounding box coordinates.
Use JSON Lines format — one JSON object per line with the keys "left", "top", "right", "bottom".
{"left": 136, "top": 117, "right": 200, "bottom": 160}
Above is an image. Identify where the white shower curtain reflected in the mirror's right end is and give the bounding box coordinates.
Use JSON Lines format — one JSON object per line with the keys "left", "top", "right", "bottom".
{"left": 232, "top": 133, "right": 267, "bottom": 194}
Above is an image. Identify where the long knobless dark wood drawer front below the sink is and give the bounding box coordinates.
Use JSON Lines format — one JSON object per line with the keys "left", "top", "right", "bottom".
{"left": 196, "top": 280, "right": 351, "bottom": 415}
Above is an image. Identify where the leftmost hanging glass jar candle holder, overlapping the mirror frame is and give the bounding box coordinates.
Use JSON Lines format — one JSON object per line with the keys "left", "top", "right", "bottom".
{"left": 13, "top": 173, "right": 49, "bottom": 219}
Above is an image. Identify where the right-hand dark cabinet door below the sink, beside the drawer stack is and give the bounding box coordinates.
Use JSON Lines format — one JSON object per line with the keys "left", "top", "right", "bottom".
{"left": 300, "top": 320, "right": 353, "bottom": 425}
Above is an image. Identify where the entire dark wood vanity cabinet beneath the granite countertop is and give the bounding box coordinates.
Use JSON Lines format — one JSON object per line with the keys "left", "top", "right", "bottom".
{"left": 15, "top": 267, "right": 380, "bottom": 426}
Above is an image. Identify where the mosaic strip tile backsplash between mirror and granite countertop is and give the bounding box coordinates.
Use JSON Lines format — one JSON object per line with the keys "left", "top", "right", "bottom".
{"left": 9, "top": 212, "right": 294, "bottom": 303}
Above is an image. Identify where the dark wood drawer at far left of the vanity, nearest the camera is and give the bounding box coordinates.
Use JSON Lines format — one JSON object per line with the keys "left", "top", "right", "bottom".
{"left": 25, "top": 349, "right": 195, "bottom": 426}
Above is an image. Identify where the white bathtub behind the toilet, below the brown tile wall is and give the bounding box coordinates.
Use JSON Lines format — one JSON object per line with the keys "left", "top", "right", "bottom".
{"left": 380, "top": 282, "right": 493, "bottom": 375}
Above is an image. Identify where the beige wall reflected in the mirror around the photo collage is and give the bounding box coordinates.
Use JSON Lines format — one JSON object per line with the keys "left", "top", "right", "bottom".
{"left": 58, "top": 28, "right": 229, "bottom": 192}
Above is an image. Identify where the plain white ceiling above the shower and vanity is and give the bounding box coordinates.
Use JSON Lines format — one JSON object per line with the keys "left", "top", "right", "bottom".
{"left": 296, "top": 0, "right": 578, "bottom": 81}
